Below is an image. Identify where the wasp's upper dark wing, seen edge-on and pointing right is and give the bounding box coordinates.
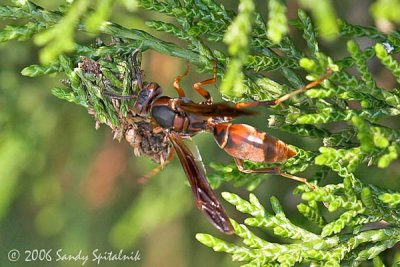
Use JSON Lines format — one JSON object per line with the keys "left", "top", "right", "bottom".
{"left": 179, "top": 102, "right": 257, "bottom": 117}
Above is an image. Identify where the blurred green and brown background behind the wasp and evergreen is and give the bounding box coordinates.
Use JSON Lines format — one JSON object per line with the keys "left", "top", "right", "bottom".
{"left": 0, "top": 0, "right": 400, "bottom": 267}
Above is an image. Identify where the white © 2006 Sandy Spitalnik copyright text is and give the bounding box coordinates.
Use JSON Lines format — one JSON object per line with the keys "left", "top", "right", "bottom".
{"left": 7, "top": 249, "right": 140, "bottom": 266}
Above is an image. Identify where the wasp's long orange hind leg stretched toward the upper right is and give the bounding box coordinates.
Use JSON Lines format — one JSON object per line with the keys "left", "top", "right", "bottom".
{"left": 235, "top": 68, "right": 332, "bottom": 108}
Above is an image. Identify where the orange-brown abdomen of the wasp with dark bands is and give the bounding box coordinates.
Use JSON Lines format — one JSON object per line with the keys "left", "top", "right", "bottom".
{"left": 214, "top": 123, "right": 296, "bottom": 162}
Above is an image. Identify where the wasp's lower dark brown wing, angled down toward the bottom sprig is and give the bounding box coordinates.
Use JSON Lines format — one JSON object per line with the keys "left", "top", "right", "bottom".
{"left": 169, "top": 132, "right": 233, "bottom": 234}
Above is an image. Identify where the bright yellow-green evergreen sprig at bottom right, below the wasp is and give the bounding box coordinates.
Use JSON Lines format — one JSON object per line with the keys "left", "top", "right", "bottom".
{"left": 196, "top": 194, "right": 400, "bottom": 266}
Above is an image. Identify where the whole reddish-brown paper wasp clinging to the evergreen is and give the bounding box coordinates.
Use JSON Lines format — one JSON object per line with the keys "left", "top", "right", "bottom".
{"left": 104, "top": 52, "right": 331, "bottom": 234}
